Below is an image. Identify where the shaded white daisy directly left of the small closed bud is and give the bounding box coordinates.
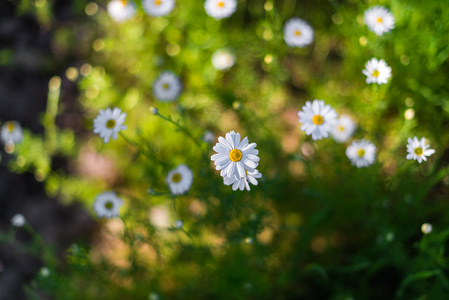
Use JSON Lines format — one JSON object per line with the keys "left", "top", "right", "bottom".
{"left": 94, "top": 107, "right": 127, "bottom": 143}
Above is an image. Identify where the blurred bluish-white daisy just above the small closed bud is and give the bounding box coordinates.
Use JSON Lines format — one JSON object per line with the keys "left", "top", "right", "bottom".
{"left": 153, "top": 71, "right": 182, "bottom": 101}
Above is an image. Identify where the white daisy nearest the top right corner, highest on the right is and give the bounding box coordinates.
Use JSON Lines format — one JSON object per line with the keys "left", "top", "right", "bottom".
{"left": 363, "top": 6, "right": 394, "bottom": 35}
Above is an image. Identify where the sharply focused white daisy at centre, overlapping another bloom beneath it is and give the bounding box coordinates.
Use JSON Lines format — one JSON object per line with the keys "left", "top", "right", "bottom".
{"left": 211, "top": 131, "right": 260, "bottom": 179}
